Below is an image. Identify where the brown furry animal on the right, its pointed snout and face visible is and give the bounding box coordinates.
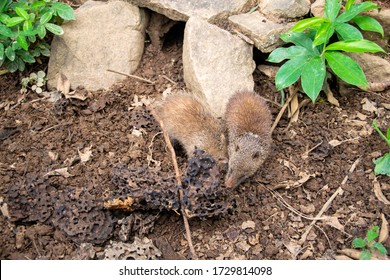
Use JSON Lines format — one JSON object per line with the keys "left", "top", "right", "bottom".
{"left": 225, "top": 91, "right": 272, "bottom": 188}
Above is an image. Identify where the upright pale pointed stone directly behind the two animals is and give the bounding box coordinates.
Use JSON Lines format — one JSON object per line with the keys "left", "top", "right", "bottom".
{"left": 183, "top": 18, "right": 255, "bottom": 117}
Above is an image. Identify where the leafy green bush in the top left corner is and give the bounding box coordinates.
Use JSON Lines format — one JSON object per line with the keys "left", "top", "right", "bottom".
{"left": 0, "top": 0, "right": 75, "bottom": 72}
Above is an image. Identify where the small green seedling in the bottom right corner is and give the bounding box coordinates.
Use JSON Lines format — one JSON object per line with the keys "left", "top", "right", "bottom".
{"left": 352, "top": 226, "right": 387, "bottom": 260}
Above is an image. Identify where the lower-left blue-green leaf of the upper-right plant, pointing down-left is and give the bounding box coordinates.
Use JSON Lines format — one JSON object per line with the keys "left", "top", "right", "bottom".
{"left": 275, "top": 57, "right": 307, "bottom": 90}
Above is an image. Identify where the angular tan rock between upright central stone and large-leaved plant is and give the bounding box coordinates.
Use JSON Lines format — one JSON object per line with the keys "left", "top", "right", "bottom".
{"left": 229, "top": 12, "right": 293, "bottom": 53}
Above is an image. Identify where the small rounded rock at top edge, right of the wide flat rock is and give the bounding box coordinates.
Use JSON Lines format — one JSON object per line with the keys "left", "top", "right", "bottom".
{"left": 260, "top": 0, "right": 310, "bottom": 18}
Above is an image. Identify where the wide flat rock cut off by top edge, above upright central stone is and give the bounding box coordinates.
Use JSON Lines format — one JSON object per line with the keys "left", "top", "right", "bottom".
{"left": 127, "top": 0, "right": 256, "bottom": 22}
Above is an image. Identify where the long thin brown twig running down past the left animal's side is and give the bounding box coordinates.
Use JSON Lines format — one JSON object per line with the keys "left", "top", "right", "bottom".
{"left": 149, "top": 108, "right": 198, "bottom": 260}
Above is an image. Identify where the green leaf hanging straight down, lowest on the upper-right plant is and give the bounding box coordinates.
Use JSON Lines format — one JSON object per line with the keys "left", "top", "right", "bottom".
{"left": 301, "top": 56, "right": 326, "bottom": 103}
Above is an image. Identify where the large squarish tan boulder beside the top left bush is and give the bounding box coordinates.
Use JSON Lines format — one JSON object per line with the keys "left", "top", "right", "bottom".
{"left": 48, "top": 1, "right": 147, "bottom": 90}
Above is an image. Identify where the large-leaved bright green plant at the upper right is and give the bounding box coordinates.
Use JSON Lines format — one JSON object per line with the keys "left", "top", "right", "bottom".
{"left": 268, "top": 0, "right": 385, "bottom": 102}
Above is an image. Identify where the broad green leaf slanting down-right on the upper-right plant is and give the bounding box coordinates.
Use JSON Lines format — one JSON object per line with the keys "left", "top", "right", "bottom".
{"left": 325, "top": 51, "right": 368, "bottom": 89}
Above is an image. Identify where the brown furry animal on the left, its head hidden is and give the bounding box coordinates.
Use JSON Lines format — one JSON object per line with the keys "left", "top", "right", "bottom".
{"left": 152, "top": 94, "right": 227, "bottom": 160}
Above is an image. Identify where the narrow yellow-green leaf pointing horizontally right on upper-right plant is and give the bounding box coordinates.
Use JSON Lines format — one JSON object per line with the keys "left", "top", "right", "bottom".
{"left": 326, "top": 39, "right": 385, "bottom": 53}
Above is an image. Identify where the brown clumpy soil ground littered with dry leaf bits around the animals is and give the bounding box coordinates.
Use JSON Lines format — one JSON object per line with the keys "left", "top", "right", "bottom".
{"left": 0, "top": 2, "right": 390, "bottom": 259}
